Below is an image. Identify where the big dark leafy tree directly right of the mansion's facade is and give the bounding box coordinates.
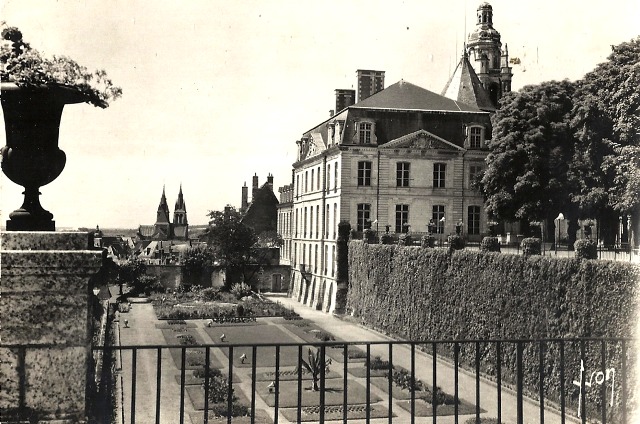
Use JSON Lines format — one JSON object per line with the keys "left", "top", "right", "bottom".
{"left": 480, "top": 80, "right": 576, "bottom": 238}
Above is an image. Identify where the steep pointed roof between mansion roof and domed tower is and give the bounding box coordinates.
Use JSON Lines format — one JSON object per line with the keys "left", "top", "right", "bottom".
{"left": 442, "top": 53, "right": 496, "bottom": 112}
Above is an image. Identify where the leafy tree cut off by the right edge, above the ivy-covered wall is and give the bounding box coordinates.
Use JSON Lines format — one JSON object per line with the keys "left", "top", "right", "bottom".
{"left": 570, "top": 37, "right": 640, "bottom": 242}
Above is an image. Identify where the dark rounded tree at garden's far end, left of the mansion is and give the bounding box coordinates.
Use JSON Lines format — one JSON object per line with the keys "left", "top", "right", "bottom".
{"left": 206, "top": 206, "right": 258, "bottom": 285}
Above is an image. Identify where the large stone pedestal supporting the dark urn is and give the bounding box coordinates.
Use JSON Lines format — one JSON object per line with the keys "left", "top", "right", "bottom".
{"left": 0, "top": 231, "right": 102, "bottom": 422}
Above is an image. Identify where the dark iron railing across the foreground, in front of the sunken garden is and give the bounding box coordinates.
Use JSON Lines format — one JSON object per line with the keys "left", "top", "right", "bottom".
{"left": 82, "top": 338, "right": 636, "bottom": 424}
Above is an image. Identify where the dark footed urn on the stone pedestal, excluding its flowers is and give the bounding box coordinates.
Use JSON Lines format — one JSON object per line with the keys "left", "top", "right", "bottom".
{"left": 0, "top": 83, "right": 87, "bottom": 231}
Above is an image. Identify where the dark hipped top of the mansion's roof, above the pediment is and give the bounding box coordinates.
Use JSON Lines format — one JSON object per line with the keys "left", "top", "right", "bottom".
{"left": 350, "top": 80, "right": 481, "bottom": 112}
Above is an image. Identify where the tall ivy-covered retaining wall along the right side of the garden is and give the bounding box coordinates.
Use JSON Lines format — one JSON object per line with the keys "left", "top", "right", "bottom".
{"left": 347, "top": 241, "right": 640, "bottom": 412}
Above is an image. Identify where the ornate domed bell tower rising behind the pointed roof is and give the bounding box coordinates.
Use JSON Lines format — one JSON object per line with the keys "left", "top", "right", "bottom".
{"left": 467, "top": 3, "right": 513, "bottom": 107}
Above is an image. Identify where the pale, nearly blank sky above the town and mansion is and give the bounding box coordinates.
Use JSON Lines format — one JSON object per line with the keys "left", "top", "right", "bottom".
{"left": 0, "top": 0, "right": 640, "bottom": 229}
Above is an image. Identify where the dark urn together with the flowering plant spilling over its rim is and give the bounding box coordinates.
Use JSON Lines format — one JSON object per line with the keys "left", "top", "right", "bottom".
{"left": 0, "top": 25, "right": 122, "bottom": 231}
